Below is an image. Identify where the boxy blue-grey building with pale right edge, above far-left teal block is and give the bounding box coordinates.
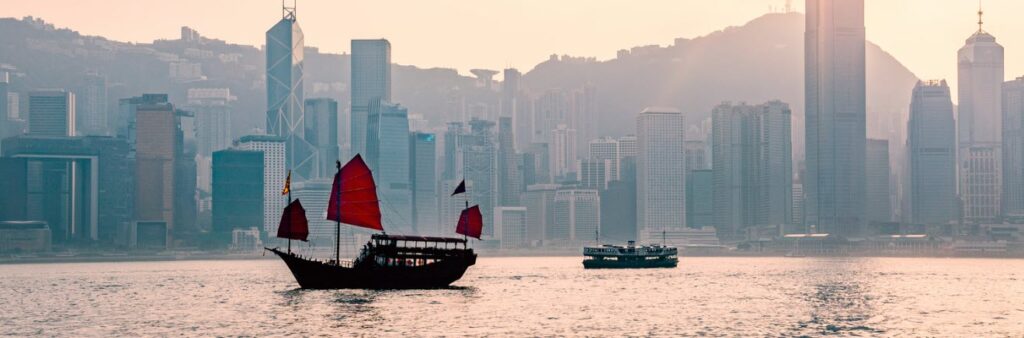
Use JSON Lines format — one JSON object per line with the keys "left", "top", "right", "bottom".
{"left": 29, "top": 90, "right": 76, "bottom": 136}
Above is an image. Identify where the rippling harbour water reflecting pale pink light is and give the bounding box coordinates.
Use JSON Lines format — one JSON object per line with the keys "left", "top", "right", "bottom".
{"left": 0, "top": 257, "right": 1024, "bottom": 336}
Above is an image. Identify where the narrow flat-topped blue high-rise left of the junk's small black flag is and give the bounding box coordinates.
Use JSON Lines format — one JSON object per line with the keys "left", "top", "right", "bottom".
{"left": 409, "top": 132, "right": 438, "bottom": 236}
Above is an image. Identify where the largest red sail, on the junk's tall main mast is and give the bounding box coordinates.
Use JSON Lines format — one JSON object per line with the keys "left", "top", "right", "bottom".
{"left": 327, "top": 155, "right": 384, "bottom": 230}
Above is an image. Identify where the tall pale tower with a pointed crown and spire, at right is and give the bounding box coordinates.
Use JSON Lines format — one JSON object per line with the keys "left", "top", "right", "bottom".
{"left": 956, "top": 2, "right": 1004, "bottom": 223}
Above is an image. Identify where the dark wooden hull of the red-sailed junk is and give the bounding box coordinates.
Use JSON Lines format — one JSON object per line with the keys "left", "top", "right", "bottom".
{"left": 266, "top": 249, "right": 476, "bottom": 289}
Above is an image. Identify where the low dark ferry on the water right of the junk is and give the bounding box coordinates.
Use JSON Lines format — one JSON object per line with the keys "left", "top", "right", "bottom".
{"left": 583, "top": 241, "right": 679, "bottom": 268}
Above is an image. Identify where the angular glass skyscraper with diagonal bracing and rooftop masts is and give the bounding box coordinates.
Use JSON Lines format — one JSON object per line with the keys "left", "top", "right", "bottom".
{"left": 265, "top": 7, "right": 318, "bottom": 180}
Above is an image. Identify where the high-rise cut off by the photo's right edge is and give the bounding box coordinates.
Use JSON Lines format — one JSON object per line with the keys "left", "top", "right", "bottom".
{"left": 1002, "top": 77, "right": 1024, "bottom": 218}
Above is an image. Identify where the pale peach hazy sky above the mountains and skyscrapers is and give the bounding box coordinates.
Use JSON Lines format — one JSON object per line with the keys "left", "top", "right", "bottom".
{"left": 6, "top": 0, "right": 1024, "bottom": 81}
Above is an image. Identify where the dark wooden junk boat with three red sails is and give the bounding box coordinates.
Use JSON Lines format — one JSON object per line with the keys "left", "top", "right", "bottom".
{"left": 266, "top": 155, "right": 482, "bottom": 289}
